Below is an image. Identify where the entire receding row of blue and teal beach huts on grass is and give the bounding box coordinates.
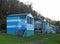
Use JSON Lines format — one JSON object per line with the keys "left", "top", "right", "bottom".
{"left": 6, "top": 13, "right": 59, "bottom": 37}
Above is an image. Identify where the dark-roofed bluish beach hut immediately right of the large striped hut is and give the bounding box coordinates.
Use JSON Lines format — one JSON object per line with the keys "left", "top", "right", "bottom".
{"left": 34, "top": 16, "right": 42, "bottom": 33}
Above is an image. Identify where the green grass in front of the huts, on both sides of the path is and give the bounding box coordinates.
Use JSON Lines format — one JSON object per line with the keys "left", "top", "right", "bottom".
{"left": 0, "top": 34, "right": 60, "bottom": 44}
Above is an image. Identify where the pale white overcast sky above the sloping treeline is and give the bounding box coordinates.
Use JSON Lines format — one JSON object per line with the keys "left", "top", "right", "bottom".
{"left": 20, "top": 0, "right": 60, "bottom": 21}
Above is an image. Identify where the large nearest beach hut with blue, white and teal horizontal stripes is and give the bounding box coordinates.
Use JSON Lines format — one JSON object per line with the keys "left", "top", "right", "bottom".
{"left": 6, "top": 13, "right": 34, "bottom": 37}
